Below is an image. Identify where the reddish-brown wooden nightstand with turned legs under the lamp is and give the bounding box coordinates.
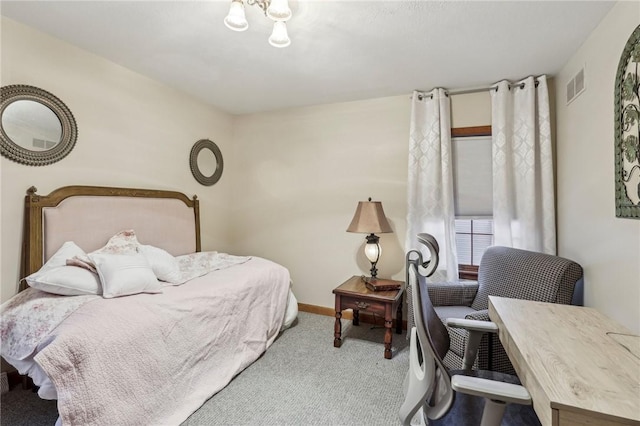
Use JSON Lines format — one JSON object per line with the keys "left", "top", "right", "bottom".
{"left": 333, "top": 275, "right": 404, "bottom": 359}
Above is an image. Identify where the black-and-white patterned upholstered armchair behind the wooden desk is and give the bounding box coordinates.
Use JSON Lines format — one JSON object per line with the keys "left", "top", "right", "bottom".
{"left": 409, "top": 240, "right": 583, "bottom": 374}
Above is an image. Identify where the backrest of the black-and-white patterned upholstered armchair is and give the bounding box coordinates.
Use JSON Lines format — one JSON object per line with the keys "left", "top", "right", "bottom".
{"left": 471, "top": 246, "right": 582, "bottom": 311}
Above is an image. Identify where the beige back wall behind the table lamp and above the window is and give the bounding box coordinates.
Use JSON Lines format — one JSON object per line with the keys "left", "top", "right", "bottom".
{"left": 230, "top": 93, "right": 491, "bottom": 307}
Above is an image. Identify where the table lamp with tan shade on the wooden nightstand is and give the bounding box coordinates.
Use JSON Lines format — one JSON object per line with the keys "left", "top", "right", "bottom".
{"left": 347, "top": 197, "right": 393, "bottom": 278}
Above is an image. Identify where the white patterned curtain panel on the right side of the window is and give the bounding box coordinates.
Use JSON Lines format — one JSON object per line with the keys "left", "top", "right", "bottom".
{"left": 491, "top": 76, "right": 556, "bottom": 254}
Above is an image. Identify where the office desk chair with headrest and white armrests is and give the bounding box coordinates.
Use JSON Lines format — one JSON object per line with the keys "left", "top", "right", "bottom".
{"left": 399, "top": 243, "right": 540, "bottom": 426}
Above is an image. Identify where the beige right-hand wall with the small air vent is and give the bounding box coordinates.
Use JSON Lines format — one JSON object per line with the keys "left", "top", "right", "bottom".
{"left": 556, "top": 2, "right": 640, "bottom": 333}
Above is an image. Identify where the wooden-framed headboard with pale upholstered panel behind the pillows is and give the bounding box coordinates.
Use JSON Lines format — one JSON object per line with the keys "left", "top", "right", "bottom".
{"left": 20, "top": 186, "right": 201, "bottom": 291}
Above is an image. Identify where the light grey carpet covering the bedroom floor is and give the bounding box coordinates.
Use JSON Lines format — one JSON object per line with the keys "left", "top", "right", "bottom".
{"left": 0, "top": 312, "right": 409, "bottom": 426}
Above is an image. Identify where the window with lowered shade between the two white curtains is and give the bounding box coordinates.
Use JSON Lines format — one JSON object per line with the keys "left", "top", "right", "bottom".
{"left": 451, "top": 126, "right": 493, "bottom": 280}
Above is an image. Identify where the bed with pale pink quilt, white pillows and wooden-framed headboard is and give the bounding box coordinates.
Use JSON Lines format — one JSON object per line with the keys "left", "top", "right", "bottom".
{"left": 0, "top": 186, "right": 297, "bottom": 425}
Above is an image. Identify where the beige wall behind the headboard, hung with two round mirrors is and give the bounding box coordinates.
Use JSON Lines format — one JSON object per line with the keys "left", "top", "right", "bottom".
{"left": 0, "top": 18, "right": 233, "bottom": 301}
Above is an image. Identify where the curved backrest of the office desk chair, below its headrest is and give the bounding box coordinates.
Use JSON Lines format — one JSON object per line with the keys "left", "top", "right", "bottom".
{"left": 406, "top": 250, "right": 455, "bottom": 419}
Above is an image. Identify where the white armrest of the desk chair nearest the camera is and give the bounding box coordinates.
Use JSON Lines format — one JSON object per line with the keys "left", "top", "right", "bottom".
{"left": 451, "top": 375, "right": 531, "bottom": 405}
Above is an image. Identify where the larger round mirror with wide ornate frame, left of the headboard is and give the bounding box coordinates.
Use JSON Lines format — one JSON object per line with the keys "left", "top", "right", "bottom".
{"left": 0, "top": 84, "right": 78, "bottom": 166}
